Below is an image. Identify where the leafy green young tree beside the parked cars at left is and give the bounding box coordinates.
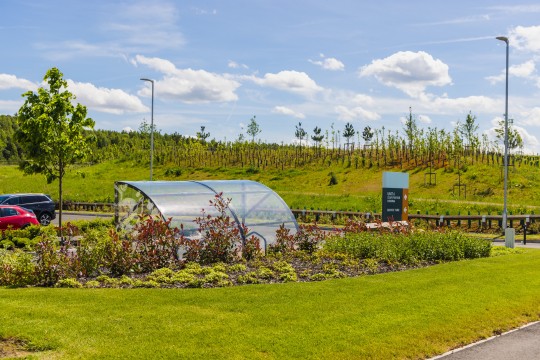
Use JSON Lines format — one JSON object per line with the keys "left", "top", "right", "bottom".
{"left": 16, "top": 68, "right": 94, "bottom": 233}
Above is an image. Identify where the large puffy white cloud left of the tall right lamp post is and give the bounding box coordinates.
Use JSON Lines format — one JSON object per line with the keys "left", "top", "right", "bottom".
{"left": 359, "top": 51, "right": 452, "bottom": 98}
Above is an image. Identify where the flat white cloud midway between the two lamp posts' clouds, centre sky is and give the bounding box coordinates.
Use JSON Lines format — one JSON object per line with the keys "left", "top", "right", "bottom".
{"left": 243, "top": 70, "right": 323, "bottom": 96}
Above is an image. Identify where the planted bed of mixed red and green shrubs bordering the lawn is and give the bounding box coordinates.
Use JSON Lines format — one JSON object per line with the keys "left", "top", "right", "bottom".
{"left": 0, "top": 195, "right": 491, "bottom": 288}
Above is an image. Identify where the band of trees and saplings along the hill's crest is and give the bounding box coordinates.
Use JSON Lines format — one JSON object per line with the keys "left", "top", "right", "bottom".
{"left": 0, "top": 115, "right": 540, "bottom": 172}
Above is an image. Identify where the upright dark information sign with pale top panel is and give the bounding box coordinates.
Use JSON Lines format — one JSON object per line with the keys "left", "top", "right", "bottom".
{"left": 382, "top": 171, "right": 409, "bottom": 222}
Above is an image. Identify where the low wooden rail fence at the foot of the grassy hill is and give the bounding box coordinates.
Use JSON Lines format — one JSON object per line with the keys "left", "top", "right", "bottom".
{"left": 64, "top": 201, "right": 540, "bottom": 229}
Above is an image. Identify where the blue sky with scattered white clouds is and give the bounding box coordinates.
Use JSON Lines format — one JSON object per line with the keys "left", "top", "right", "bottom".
{"left": 0, "top": 0, "right": 540, "bottom": 154}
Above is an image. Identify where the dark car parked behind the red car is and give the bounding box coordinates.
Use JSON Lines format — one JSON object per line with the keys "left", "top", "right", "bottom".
{"left": 0, "top": 194, "right": 56, "bottom": 225}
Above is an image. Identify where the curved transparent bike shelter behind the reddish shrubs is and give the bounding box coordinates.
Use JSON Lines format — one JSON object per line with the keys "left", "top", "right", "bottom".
{"left": 114, "top": 180, "right": 298, "bottom": 250}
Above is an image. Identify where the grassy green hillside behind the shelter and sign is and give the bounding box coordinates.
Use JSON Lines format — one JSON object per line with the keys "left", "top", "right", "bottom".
{"left": 0, "top": 155, "right": 540, "bottom": 214}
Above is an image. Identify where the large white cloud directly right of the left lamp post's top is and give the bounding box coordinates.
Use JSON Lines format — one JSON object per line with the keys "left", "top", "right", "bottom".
{"left": 132, "top": 55, "right": 240, "bottom": 103}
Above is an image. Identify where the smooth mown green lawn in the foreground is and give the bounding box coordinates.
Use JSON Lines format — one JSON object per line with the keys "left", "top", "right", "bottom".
{"left": 0, "top": 250, "right": 540, "bottom": 359}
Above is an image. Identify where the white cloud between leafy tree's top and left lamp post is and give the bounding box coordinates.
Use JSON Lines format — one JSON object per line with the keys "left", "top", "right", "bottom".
{"left": 67, "top": 80, "right": 148, "bottom": 114}
